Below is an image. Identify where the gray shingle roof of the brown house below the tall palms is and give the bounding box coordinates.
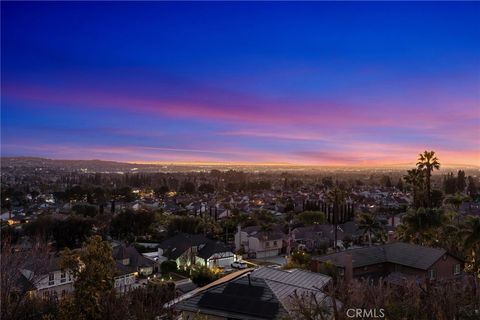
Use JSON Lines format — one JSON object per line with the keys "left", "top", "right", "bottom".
{"left": 313, "top": 242, "right": 446, "bottom": 270}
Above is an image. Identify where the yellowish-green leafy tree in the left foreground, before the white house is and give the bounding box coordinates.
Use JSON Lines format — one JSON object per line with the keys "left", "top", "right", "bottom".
{"left": 60, "top": 236, "right": 115, "bottom": 320}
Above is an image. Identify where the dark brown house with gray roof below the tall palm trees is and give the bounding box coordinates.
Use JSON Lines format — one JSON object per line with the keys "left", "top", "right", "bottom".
{"left": 312, "top": 242, "right": 463, "bottom": 281}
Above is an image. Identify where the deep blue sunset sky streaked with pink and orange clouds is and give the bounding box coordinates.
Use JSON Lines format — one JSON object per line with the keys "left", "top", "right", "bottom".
{"left": 1, "top": 2, "right": 480, "bottom": 166}
